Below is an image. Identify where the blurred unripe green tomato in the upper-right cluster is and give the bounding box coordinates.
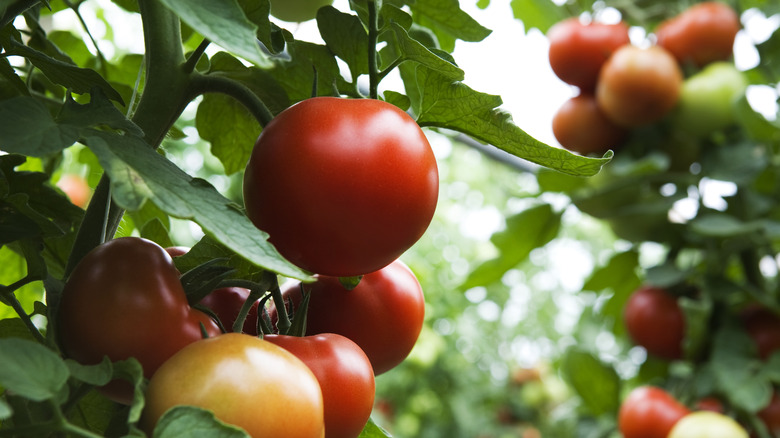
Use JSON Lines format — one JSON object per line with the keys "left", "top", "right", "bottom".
{"left": 674, "top": 61, "right": 748, "bottom": 136}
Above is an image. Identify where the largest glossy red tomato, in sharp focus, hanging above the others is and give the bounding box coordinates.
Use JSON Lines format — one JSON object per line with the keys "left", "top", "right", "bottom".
{"left": 244, "top": 97, "right": 439, "bottom": 277}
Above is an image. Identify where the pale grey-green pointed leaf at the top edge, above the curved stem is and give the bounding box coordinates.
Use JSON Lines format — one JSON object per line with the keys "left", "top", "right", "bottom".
{"left": 162, "top": 0, "right": 271, "bottom": 67}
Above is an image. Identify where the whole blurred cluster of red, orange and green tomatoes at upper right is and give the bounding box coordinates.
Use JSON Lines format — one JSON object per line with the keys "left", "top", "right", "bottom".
{"left": 548, "top": 2, "right": 747, "bottom": 155}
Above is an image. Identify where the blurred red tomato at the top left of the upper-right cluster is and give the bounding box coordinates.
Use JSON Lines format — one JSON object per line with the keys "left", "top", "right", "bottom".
{"left": 547, "top": 17, "right": 629, "bottom": 91}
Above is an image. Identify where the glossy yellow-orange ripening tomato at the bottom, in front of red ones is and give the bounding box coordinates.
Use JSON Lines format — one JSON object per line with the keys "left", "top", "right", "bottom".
{"left": 142, "top": 333, "right": 325, "bottom": 438}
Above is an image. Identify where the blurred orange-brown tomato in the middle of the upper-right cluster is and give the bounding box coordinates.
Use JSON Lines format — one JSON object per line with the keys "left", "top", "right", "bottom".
{"left": 596, "top": 45, "right": 683, "bottom": 128}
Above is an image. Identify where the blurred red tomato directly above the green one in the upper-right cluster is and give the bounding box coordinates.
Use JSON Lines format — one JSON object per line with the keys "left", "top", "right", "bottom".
{"left": 655, "top": 2, "right": 740, "bottom": 67}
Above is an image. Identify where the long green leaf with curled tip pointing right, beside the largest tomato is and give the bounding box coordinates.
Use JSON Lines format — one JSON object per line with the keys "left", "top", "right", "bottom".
{"left": 410, "top": 67, "right": 612, "bottom": 176}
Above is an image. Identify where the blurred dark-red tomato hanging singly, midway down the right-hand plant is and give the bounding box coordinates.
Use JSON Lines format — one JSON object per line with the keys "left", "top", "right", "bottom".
{"left": 623, "top": 286, "right": 685, "bottom": 360}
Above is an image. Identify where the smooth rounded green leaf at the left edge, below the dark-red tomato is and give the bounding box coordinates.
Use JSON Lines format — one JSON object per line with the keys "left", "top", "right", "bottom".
{"left": 0, "top": 338, "right": 69, "bottom": 401}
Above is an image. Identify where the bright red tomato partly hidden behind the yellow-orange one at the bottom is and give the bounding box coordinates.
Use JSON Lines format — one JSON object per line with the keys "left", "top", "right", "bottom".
{"left": 263, "top": 333, "right": 376, "bottom": 438}
